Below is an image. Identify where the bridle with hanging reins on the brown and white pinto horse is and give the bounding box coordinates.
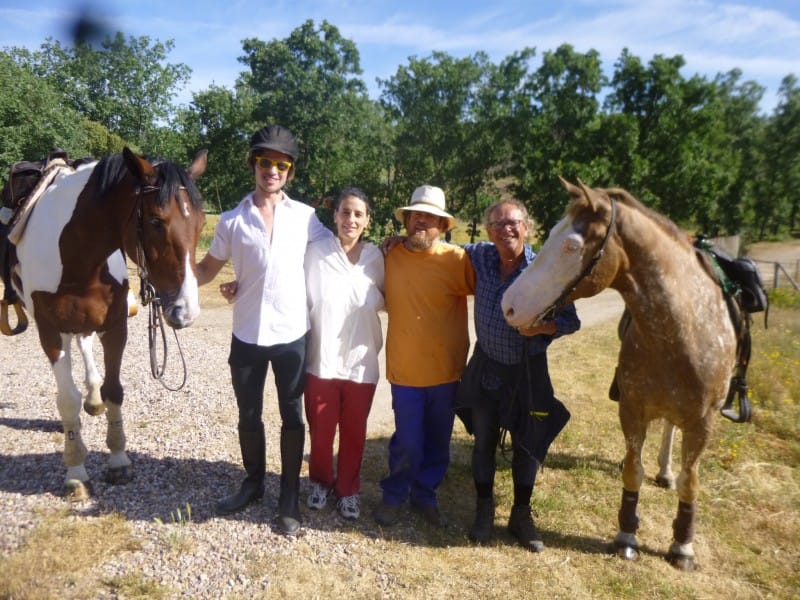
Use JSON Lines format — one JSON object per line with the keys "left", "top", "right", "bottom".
{"left": 134, "top": 185, "right": 191, "bottom": 392}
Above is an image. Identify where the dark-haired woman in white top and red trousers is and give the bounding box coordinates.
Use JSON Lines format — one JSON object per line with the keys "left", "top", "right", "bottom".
{"left": 305, "top": 188, "right": 384, "bottom": 519}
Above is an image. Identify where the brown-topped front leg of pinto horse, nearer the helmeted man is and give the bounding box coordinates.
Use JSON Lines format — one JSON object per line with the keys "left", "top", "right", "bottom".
{"left": 100, "top": 320, "right": 133, "bottom": 485}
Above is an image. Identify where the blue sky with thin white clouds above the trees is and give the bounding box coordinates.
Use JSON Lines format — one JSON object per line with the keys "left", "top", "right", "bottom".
{"left": 0, "top": 0, "right": 800, "bottom": 112}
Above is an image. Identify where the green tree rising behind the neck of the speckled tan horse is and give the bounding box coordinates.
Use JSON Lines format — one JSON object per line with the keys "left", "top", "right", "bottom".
{"left": 606, "top": 49, "right": 740, "bottom": 234}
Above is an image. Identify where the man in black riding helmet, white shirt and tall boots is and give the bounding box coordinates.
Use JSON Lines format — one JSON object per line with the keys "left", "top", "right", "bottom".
{"left": 197, "top": 125, "right": 333, "bottom": 534}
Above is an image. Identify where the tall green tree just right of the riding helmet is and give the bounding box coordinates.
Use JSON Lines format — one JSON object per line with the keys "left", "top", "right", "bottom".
{"left": 239, "top": 20, "right": 385, "bottom": 205}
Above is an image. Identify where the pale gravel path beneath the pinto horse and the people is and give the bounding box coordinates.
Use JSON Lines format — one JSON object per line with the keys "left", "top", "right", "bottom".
{"left": 0, "top": 284, "right": 621, "bottom": 598}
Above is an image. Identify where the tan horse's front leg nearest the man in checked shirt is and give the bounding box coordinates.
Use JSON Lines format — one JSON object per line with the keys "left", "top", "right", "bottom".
{"left": 614, "top": 403, "right": 647, "bottom": 560}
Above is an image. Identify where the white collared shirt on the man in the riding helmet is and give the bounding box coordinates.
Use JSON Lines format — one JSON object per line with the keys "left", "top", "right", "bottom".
{"left": 208, "top": 193, "right": 334, "bottom": 346}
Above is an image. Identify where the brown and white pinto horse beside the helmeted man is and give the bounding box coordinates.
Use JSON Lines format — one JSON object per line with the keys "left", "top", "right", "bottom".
{"left": 11, "top": 148, "right": 206, "bottom": 500}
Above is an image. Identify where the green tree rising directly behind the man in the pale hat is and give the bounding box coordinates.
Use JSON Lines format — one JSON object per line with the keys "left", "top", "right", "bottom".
{"left": 380, "top": 52, "right": 500, "bottom": 238}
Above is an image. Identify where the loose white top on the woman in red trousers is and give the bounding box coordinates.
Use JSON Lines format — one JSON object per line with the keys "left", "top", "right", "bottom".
{"left": 305, "top": 237, "right": 384, "bottom": 383}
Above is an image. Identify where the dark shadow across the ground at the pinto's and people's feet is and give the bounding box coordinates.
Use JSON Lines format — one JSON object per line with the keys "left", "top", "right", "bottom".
{"left": 0, "top": 428, "right": 620, "bottom": 554}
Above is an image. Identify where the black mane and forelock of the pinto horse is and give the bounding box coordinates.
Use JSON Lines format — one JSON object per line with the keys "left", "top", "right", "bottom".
{"left": 92, "top": 152, "right": 203, "bottom": 209}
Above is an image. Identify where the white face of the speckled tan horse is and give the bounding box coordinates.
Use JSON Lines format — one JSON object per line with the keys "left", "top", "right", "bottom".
{"left": 501, "top": 217, "right": 584, "bottom": 327}
